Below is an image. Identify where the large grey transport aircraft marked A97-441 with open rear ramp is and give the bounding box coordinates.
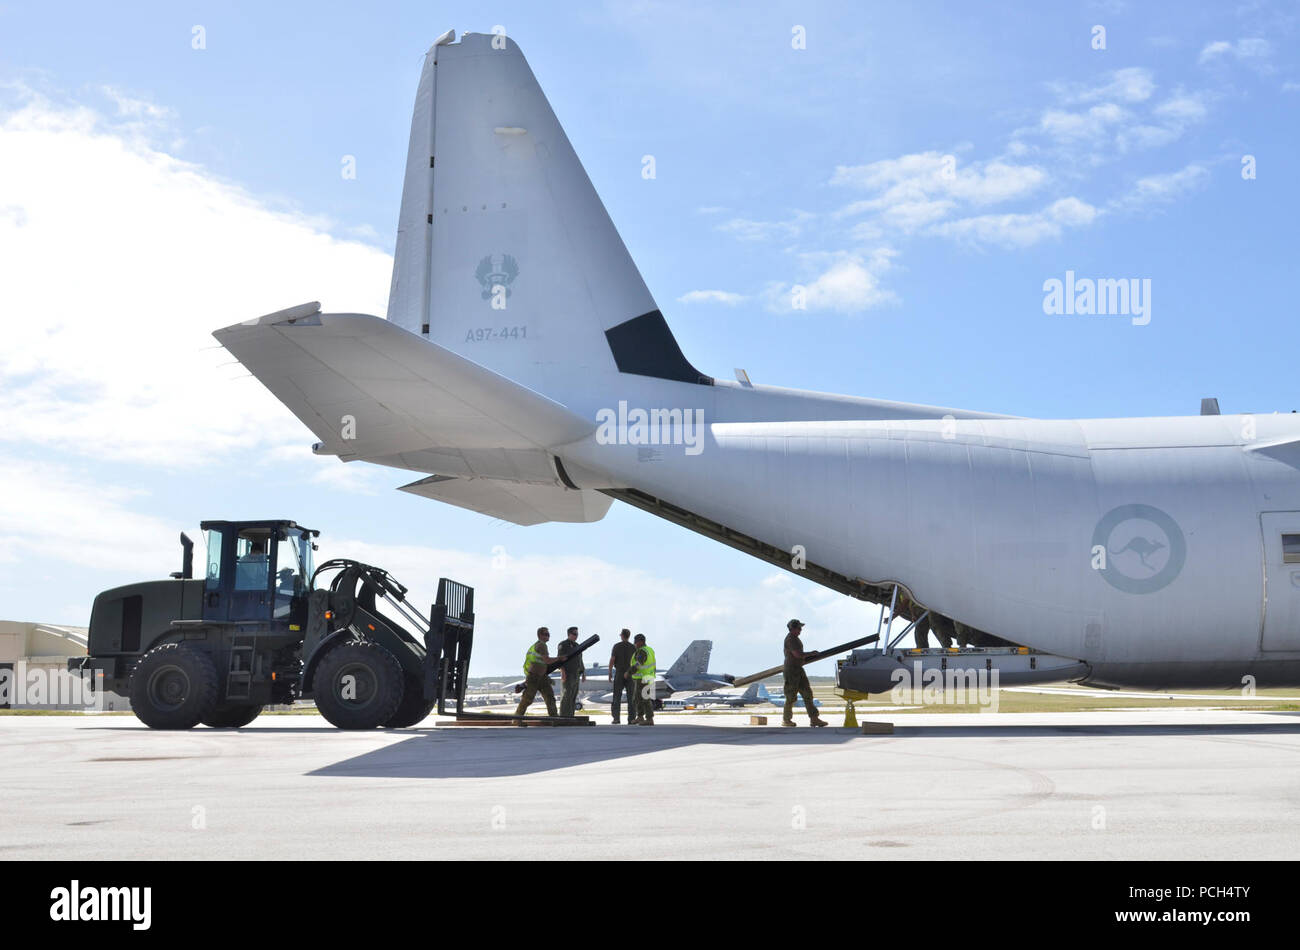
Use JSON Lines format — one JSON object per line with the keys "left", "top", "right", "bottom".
{"left": 216, "top": 32, "right": 1300, "bottom": 691}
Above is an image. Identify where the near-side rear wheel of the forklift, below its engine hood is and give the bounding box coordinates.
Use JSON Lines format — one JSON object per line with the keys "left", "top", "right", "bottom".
{"left": 127, "top": 643, "right": 217, "bottom": 729}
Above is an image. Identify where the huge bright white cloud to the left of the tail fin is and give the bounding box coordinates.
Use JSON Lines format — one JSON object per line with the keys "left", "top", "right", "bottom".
{"left": 0, "top": 86, "right": 391, "bottom": 468}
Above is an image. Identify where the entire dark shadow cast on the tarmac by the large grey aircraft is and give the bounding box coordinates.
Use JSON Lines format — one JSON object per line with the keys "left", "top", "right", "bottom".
{"left": 295, "top": 721, "right": 1300, "bottom": 778}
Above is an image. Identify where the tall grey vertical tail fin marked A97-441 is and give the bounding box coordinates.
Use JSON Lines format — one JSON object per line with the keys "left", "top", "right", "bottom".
{"left": 387, "top": 34, "right": 709, "bottom": 402}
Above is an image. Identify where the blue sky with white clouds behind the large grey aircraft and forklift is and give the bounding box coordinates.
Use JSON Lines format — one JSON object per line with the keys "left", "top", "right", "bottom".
{"left": 0, "top": 1, "right": 1300, "bottom": 673}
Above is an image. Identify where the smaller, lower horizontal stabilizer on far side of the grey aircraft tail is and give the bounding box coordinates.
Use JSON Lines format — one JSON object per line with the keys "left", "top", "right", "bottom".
{"left": 402, "top": 476, "right": 614, "bottom": 525}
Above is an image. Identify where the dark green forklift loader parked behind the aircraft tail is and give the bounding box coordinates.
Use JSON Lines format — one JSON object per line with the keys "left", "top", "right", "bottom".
{"left": 68, "top": 520, "right": 475, "bottom": 729}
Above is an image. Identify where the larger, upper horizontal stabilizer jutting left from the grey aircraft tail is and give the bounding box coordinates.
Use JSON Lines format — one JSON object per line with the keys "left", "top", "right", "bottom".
{"left": 213, "top": 304, "right": 595, "bottom": 462}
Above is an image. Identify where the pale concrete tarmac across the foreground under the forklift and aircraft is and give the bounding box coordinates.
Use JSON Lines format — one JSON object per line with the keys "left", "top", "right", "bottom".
{"left": 0, "top": 710, "right": 1300, "bottom": 860}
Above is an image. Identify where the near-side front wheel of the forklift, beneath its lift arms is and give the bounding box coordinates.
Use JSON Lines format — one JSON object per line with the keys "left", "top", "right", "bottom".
{"left": 312, "top": 641, "right": 406, "bottom": 729}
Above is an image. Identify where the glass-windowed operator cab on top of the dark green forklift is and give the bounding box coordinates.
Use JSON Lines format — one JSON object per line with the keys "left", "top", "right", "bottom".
{"left": 199, "top": 521, "right": 320, "bottom": 629}
